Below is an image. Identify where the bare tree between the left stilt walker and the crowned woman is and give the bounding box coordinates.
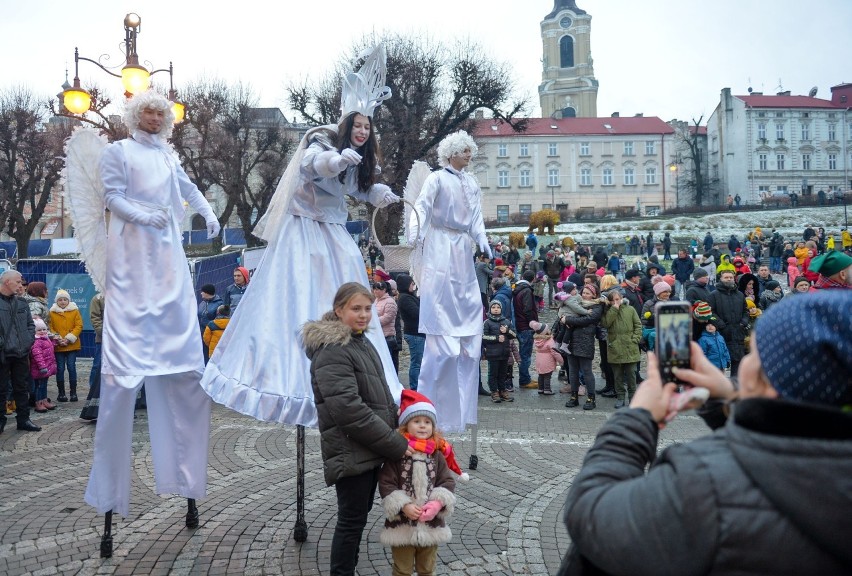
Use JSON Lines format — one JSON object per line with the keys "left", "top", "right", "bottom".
{"left": 172, "top": 80, "right": 292, "bottom": 246}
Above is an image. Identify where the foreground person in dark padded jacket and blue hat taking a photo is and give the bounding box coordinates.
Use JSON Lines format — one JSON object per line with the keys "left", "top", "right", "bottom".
{"left": 560, "top": 291, "right": 852, "bottom": 575}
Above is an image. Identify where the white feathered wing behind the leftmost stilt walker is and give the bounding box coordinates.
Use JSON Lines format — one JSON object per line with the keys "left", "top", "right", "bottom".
{"left": 62, "top": 128, "right": 109, "bottom": 294}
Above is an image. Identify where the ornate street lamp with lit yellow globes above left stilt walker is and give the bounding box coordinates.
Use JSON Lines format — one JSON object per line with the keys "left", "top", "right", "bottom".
{"left": 62, "top": 12, "right": 184, "bottom": 123}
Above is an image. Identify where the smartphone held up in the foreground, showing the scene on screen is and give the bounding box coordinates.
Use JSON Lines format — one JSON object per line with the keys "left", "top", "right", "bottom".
{"left": 654, "top": 302, "right": 692, "bottom": 386}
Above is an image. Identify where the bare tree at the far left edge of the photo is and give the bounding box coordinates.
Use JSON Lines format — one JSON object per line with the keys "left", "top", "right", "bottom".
{"left": 0, "top": 88, "right": 71, "bottom": 258}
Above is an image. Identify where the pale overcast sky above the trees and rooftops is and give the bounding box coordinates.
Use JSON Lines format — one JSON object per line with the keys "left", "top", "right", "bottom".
{"left": 0, "top": 0, "right": 852, "bottom": 121}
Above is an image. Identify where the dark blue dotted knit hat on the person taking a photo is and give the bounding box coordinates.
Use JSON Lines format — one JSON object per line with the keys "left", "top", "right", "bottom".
{"left": 755, "top": 290, "right": 852, "bottom": 407}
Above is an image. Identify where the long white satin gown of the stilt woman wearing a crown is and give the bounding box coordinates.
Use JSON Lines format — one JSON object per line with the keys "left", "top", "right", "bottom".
{"left": 201, "top": 125, "right": 402, "bottom": 427}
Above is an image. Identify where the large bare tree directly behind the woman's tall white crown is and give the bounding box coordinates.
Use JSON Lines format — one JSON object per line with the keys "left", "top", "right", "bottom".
{"left": 288, "top": 34, "right": 528, "bottom": 244}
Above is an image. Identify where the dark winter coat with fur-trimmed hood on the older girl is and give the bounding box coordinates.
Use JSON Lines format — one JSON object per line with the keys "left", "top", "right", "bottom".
{"left": 302, "top": 312, "right": 408, "bottom": 486}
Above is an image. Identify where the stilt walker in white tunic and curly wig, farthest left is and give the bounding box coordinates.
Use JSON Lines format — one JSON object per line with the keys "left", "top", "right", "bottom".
{"left": 67, "top": 91, "right": 219, "bottom": 557}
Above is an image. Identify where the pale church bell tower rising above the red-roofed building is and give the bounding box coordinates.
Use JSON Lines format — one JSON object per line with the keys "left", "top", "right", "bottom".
{"left": 538, "top": 0, "right": 598, "bottom": 118}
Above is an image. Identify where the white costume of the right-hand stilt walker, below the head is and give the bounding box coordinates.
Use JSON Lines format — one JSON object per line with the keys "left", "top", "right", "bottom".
{"left": 410, "top": 166, "right": 485, "bottom": 432}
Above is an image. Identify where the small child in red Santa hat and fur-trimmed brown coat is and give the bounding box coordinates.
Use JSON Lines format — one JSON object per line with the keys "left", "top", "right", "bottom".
{"left": 379, "top": 390, "right": 469, "bottom": 574}
